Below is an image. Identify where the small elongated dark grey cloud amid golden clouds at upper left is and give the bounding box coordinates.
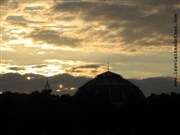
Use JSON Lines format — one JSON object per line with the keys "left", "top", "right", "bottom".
{"left": 28, "top": 29, "right": 81, "bottom": 47}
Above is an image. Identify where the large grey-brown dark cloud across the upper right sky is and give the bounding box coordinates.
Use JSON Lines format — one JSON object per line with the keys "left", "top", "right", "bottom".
{"left": 54, "top": 0, "right": 177, "bottom": 46}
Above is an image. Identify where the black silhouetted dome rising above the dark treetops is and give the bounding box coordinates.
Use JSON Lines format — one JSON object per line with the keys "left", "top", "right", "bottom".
{"left": 76, "top": 71, "right": 145, "bottom": 104}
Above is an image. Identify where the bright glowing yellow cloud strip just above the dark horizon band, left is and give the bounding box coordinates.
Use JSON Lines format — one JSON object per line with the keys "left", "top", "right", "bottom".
{"left": 1, "top": 55, "right": 107, "bottom": 77}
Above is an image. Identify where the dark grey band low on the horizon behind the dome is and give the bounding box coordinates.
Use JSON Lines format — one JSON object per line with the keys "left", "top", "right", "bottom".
{"left": 0, "top": 73, "right": 180, "bottom": 96}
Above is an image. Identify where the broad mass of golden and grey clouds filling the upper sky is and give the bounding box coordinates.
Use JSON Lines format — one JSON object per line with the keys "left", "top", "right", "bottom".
{"left": 4, "top": 1, "right": 176, "bottom": 54}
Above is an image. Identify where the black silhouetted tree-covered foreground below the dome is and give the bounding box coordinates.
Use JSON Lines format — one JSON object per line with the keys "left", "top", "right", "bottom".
{"left": 0, "top": 92, "right": 180, "bottom": 135}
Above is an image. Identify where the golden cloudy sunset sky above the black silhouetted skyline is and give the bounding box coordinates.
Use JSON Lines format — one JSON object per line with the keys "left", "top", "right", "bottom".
{"left": 0, "top": 0, "right": 180, "bottom": 93}
